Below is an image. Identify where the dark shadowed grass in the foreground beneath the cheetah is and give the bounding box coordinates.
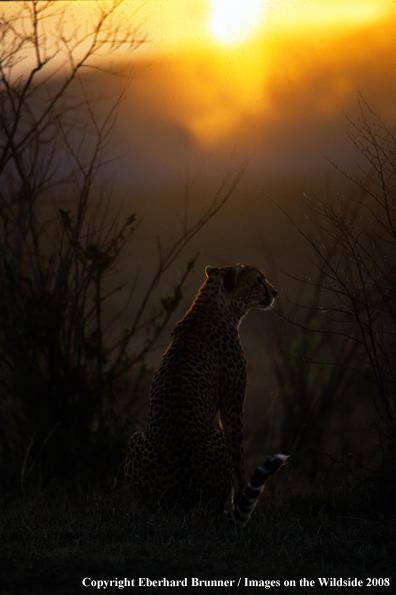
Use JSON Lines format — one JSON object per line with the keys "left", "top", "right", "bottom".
{"left": 0, "top": 487, "right": 396, "bottom": 595}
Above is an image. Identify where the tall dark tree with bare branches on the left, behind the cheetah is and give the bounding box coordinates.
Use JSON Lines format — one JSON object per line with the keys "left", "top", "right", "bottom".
{"left": 0, "top": 0, "right": 248, "bottom": 488}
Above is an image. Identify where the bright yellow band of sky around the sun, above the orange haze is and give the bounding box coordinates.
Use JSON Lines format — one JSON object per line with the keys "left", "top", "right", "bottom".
{"left": 122, "top": 0, "right": 394, "bottom": 51}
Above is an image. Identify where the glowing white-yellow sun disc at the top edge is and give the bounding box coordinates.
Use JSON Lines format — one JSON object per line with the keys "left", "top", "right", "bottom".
{"left": 209, "top": 0, "right": 266, "bottom": 45}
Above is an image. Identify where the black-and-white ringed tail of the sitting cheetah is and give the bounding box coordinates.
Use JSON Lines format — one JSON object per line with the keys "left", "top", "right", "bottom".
{"left": 234, "top": 455, "right": 289, "bottom": 527}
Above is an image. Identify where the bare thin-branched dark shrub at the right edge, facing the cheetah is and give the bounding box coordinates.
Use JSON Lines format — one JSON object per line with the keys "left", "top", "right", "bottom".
{"left": 278, "top": 97, "right": 396, "bottom": 488}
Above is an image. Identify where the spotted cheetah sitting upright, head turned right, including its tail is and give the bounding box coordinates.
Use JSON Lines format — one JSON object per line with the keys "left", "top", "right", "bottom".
{"left": 125, "top": 264, "right": 288, "bottom": 525}
